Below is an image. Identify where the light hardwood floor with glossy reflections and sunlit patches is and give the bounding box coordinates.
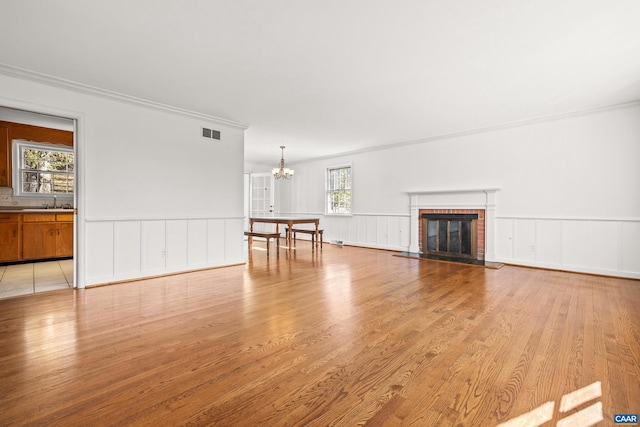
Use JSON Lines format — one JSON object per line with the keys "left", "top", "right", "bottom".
{"left": 0, "top": 242, "right": 640, "bottom": 426}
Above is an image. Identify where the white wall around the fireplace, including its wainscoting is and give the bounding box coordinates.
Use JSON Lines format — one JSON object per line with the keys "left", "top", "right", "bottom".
{"left": 280, "top": 104, "right": 640, "bottom": 277}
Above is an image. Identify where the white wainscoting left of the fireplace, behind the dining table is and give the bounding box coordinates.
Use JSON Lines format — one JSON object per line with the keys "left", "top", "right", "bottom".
{"left": 270, "top": 213, "right": 411, "bottom": 251}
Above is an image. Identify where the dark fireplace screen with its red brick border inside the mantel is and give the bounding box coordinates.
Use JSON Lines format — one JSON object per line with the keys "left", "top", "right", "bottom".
{"left": 422, "top": 214, "right": 478, "bottom": 259}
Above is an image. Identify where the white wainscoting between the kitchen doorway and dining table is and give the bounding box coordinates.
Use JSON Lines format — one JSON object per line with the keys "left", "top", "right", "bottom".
{"left": 85, "top": 218, "right": 245, "bottom": 285}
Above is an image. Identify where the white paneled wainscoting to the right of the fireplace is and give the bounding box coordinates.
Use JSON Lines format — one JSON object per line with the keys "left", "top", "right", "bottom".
{"left": 496, "top": 217, "right": 640, "bottom": 279}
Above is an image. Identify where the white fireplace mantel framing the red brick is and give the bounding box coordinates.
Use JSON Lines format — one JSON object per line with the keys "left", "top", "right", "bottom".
{"left": 407, "top": 188, "right": 499, "bottom": 261}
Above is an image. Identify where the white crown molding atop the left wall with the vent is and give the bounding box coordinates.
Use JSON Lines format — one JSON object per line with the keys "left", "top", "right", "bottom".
{"left": 0, "top": 63, "right": 249, "bottom": 130}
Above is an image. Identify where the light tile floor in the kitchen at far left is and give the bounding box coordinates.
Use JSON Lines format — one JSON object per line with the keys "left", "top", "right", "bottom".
{"left": 0, "top": 259, "right": 73, "bottom": 298}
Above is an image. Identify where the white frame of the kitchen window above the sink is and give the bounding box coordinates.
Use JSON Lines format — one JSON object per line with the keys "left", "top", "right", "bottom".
{"left": 11, "top": 139, "right": 76, "bottom": 200}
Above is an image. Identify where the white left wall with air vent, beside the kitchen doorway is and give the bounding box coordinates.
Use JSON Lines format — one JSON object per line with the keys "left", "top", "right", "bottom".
{"left": 0, "top": 73, "right": 245, "bottom": 287}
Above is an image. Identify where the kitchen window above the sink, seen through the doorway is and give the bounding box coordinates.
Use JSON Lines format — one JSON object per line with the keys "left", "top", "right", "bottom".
{"left": 12, "top": 140, "right": 75, "bottom": 198}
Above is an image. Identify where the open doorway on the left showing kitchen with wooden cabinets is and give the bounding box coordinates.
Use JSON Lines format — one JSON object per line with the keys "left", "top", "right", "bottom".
{"left": 0, "top": 106, "right": 77, "bottom": 298}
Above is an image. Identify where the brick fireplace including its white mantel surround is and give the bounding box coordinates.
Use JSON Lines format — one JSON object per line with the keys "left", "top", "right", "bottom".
{"left": 409, "top": 189, "right": 498, "bottom": 261}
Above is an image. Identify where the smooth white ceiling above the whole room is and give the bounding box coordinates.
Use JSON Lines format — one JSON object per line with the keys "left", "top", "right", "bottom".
{"left": 0, "top": 0, "right": 640, "bottom": 165}
